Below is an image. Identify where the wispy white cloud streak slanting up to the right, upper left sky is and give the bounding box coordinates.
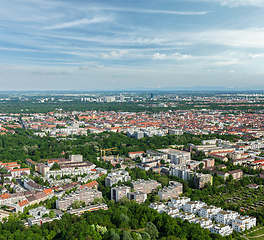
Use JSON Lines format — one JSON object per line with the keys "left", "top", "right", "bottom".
{"left": 44, "top": 16, "right": 110, "bottom": 30}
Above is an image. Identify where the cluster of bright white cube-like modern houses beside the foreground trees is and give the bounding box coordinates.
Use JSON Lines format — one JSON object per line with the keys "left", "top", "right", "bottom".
{"left": 149, "top": 197, "right": 256, "bottom": 236}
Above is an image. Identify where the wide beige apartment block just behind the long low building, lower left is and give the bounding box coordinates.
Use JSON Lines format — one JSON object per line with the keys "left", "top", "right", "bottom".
{"left": 56, "top": 189, "right": 102, "bottom": 211}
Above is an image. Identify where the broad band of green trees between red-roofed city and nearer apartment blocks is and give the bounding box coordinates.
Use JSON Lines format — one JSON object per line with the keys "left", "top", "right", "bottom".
{"left": 0, "top": 129, "right": 237, "bottom": 168}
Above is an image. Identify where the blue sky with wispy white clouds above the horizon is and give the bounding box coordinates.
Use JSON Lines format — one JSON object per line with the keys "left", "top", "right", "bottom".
{"left": 0, "top": 0, "right": 264, "bottom": 91}
